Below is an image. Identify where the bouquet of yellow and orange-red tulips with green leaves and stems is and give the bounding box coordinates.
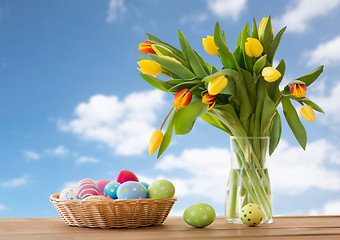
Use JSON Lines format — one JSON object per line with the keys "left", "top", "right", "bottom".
{"left": 138, "top": 16, "right": 323, "bottom": 223}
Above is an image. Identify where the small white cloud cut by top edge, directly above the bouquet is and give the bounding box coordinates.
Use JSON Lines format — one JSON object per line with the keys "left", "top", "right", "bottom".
{"left": 207, "top": 0, "right": 247, "bottom": 21}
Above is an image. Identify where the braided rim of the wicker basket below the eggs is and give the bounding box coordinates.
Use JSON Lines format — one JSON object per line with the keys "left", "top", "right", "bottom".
{"left": 50, "top": 193, "right": 178, "bottom": 204}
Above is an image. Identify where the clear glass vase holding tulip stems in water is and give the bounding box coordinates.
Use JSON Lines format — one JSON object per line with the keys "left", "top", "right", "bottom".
{"left": 225, "top": 137, "right": 273, "bottom": 223}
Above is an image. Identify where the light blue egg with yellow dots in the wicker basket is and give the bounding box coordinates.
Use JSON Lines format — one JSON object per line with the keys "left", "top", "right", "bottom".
{"left": 117, "top": 181, "right": 147, "bottom": 199}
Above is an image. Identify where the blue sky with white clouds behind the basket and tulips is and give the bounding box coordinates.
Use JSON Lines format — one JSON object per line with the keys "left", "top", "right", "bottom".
{"left": 0, "top": 0, "right": 340, "bottom": 217}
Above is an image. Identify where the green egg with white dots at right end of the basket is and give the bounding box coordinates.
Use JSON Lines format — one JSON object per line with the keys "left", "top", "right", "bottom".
{"left": 148, "top": 180, "right": 175, "bottom": 198}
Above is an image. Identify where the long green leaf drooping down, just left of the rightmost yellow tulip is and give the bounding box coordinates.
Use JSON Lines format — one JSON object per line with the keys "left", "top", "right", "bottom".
{"left": 282, "top": 98, "right": 307, "bottom": 149}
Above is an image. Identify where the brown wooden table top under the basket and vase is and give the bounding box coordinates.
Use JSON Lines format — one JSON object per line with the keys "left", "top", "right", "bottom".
{"left": 0, "top": 216, "right": 340, "bottom": 240}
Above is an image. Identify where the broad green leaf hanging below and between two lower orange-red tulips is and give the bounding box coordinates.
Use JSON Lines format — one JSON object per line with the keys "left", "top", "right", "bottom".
{"left": 174, "top": 98, "right": 207, "bottom": 135}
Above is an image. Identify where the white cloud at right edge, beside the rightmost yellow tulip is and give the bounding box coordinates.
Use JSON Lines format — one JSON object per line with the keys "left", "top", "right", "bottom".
{"left": 311, "top": 82, "right": 340, "bottom": 125}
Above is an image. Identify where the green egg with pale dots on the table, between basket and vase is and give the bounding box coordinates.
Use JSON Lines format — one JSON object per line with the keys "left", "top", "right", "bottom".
{"left": 183, "top": 203, "right": 216, "bottom": 228}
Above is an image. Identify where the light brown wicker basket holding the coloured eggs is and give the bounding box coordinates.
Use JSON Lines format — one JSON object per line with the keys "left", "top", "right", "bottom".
{"left": 50, "top": 193, "right": 177, "bottom": 228}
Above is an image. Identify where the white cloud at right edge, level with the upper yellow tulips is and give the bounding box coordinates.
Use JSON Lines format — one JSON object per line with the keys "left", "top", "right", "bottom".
{"left": 304, "top": 35, "right": 340, "bottom": 66}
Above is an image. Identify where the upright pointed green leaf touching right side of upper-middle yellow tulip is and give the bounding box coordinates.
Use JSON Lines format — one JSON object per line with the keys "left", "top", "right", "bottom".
{"left": 214, "top": 22, "right": 238, "bottom": 69}
